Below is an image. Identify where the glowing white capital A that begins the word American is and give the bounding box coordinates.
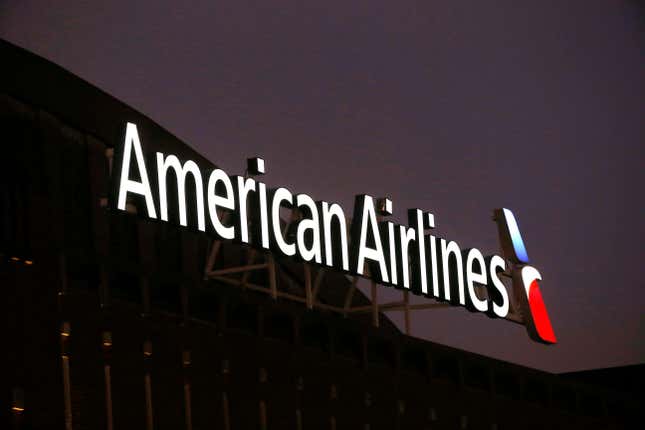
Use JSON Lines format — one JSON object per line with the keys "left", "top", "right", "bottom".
{"left": 117, "top": 122, "right": 157, "bottom": 218}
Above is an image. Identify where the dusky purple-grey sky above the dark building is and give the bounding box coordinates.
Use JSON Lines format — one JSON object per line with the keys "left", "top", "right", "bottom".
{"left": 0, "top": 0, "right": 645, "bottom": 372}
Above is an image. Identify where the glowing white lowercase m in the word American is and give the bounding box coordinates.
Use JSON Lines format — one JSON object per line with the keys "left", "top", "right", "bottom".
{"left": 157, "top": 152, "right": 206, "bottom": 231}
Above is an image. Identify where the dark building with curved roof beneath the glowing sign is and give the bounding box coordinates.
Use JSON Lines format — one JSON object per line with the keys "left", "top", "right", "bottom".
{"left": 0, "top": 42, "right": 638, "bottom": 430}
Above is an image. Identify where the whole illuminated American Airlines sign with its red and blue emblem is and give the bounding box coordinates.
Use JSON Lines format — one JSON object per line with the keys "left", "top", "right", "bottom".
{"left": 113, "top": 123, "right": 555, "bottom": 343}
